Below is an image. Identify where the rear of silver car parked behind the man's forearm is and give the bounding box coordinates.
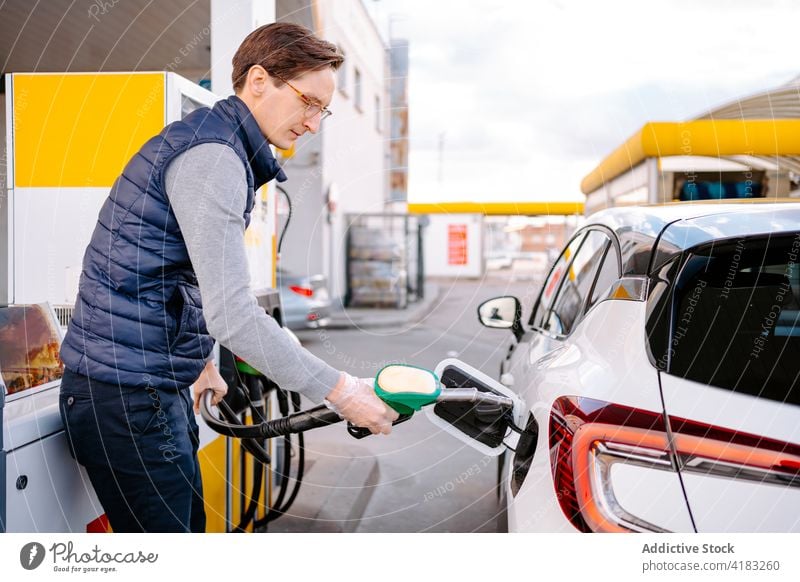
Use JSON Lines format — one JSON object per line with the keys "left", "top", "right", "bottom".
{"left": 277, "top": 268, "right": 331, "bottom": 330}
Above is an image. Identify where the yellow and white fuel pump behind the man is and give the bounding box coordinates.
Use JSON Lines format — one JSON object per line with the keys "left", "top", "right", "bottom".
{"left": 0, "top": 72, "right": 282, "bottom": 532}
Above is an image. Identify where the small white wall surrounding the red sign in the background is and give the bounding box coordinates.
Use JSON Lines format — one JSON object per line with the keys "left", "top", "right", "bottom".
{"left": 424, "top": 214, "right": 484, "bottom": 277}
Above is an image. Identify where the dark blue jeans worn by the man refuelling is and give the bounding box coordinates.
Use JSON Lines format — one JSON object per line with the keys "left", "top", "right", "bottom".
{"left": 59, "top": 369, "right": 206, "bottom": 532}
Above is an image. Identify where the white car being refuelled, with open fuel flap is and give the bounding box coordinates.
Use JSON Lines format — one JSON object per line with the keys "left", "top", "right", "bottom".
{"left": 478, "top": 203, "right": 800, "bottom": 532}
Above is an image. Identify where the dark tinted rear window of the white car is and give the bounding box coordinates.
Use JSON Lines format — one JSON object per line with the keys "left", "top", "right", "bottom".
{"left": 667, "top": 234, "right": 800, "bottom": 404}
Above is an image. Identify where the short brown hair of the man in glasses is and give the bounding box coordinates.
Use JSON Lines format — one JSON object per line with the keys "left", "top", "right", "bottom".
{"left": 231, "top": 22, "right": 344, "bottom": 92}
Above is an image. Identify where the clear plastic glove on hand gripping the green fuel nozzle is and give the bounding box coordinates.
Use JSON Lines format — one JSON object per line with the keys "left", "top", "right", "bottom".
{"left": 326, "top": 372, "right": 400, "bottom": 434}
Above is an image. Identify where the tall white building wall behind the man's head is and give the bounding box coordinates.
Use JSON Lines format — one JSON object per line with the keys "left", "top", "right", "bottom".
{"left": 244, "top": 0, "right": 389, "bottom": 297}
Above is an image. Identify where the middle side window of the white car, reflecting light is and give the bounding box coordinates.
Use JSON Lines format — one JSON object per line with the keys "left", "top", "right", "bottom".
{"left": 542, "top": 230, "right": 611, "bottom": 335}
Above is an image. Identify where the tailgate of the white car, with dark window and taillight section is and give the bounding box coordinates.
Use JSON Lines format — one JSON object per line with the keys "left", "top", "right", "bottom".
{"left": 656, "top": 233, "right": 800, "bottom": 532}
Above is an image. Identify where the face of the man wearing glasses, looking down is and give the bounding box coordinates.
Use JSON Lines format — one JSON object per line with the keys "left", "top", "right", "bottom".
{"left": 239, "top": 67, "right": 336, "bottom": 149}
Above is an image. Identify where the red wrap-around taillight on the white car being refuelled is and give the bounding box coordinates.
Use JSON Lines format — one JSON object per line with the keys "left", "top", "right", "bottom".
{"left": 550, "top": 396, "right": 800, "bottom": 532}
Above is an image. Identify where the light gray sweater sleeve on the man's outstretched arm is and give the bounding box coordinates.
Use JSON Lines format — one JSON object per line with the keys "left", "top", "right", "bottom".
{"left": 165, "top": 143, "right": 339, "bottom": 402}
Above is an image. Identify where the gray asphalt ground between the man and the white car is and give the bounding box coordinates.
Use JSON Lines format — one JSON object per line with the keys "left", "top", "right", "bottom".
{"left": 275, "top": 271, "right": 539, "bottom": 532}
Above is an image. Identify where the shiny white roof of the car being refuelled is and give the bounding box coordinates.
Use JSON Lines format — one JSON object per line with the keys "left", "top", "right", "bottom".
{"left": 586, "top": 200, "right": 800, "bottom": 274}
